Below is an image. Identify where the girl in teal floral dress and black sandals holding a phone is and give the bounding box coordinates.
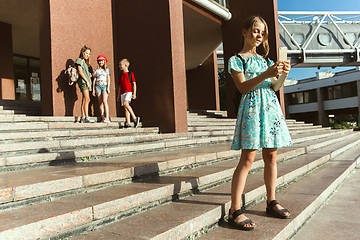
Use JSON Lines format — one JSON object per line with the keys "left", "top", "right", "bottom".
{"left": 228, "top": 16, "right": 292, "bottom": 230}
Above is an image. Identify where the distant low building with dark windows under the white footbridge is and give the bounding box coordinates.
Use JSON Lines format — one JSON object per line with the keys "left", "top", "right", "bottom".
{"left": 284, "top": 67, "right": 360, "bottom": 126}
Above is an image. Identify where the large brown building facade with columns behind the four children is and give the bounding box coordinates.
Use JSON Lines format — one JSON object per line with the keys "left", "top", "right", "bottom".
{"left": 0, "top": 0, "right": 279, "bottom": 132}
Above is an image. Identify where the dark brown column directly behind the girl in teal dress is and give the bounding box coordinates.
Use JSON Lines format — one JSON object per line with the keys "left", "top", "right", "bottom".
{"left": 222, "top": 0, "right": 284, "bottom": 117}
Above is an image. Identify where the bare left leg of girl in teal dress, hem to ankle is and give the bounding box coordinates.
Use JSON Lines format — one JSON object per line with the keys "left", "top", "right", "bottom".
{"left": 231, "top": 149, "right": 256, "bottom": 212}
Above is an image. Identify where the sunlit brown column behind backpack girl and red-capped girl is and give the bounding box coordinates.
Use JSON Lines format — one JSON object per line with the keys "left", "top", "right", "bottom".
{"left": 39, "top": 0, "right": 116, "bottom": 116}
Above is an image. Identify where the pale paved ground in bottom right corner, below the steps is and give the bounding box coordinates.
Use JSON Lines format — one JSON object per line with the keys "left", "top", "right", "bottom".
{"left": 293, "top": 169, "right": 360, "bottom": 240}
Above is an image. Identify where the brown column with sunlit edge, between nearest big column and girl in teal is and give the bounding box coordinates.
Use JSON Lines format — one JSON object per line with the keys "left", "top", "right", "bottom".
{"left": 186, "top": 51, "right": 220, "bottom": 110}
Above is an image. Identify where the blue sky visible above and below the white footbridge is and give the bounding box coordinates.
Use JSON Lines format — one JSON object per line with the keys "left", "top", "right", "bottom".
{"left": 277, "top": 0, "right": 360, "bottom": 80}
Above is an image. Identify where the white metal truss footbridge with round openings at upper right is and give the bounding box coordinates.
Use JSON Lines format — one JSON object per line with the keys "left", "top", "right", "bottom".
{"left": 279, "top": 11, "right": 360, "bottom": 66}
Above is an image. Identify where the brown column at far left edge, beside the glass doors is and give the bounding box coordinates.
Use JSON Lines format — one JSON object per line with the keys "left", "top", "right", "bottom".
{"left": 0, "top": 22, "right": 15, "bottom": 100}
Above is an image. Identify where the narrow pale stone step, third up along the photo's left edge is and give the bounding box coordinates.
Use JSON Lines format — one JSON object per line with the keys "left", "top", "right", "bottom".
{"left": 0, "top": 133, "right": 232, "bottom": 170}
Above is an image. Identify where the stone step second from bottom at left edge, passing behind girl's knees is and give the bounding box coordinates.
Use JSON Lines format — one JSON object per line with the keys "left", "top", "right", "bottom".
{"left": 0, "top": 139, "right": 312, "bottom": 208}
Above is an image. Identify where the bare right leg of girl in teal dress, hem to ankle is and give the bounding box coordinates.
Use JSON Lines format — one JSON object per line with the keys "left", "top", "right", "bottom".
{"left": 262, "top": 148, "right": 277, "bottom": 202}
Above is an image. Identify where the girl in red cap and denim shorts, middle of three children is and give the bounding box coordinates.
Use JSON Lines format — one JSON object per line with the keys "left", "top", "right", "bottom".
{"left": 93, "top": 54, "right": 110, "bottom": 122}
